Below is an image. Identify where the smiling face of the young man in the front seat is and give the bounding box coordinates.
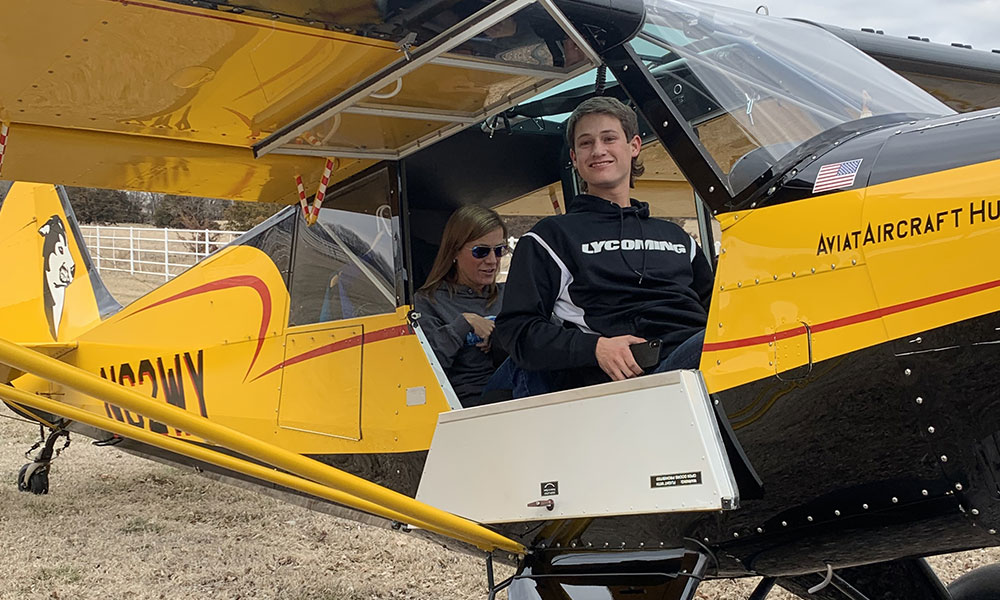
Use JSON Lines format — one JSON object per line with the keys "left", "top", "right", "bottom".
{"left": 570, "top": 113, "right": 641, "bottom": 193}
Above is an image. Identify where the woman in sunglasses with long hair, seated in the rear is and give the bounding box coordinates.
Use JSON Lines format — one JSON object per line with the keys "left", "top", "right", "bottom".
{"left": 416, "top": 206, "right": 508, "bottom": 406}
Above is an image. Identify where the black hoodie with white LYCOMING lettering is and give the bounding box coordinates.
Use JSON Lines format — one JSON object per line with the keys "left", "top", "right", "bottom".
{"left": 495, "top": 194, "right": 713, "bottom": 383}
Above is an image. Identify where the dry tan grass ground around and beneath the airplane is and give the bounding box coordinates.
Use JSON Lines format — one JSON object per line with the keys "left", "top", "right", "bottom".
{"left": 0, "top": 276, "right": 1000, "bottom": 600}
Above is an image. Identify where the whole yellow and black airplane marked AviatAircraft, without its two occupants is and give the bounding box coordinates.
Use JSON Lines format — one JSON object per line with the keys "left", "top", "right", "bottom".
{"left": 0, "top": 0, "right": 1000, "bottom": 599}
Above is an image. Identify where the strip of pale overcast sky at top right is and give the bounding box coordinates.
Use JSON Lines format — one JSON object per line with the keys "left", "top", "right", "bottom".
{"left": 706, "top": 0, "right": 1000, "bottom": 51}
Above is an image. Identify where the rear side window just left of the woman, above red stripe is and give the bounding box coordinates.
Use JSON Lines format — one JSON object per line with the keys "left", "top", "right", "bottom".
{"left": 289, "top": 169, "right": 402, "bottom": 326}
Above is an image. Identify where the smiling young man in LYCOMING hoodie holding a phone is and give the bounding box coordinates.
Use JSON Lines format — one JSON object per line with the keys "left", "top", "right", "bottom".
{"left": 495, "top": 97, "right": 713, "bottom": 397}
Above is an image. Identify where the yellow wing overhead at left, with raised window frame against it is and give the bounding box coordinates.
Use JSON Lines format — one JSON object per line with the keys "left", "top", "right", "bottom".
{"left": 0, "top": 0, "right": 597, "bottom": 203}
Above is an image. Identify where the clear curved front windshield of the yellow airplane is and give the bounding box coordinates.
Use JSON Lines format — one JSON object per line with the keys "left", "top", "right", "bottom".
{"left": 631, "top": 0, "right": 954, "bottom": 195}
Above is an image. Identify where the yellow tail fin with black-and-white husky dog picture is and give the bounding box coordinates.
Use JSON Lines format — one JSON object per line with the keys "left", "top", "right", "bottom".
{"left": 0, "top": 182, "right": 121, "bottom": 344}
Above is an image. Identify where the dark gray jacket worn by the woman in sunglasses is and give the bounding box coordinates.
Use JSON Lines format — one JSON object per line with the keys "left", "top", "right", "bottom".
{"left": 415, "top": 282, "right": 504, "bottom": 406}
